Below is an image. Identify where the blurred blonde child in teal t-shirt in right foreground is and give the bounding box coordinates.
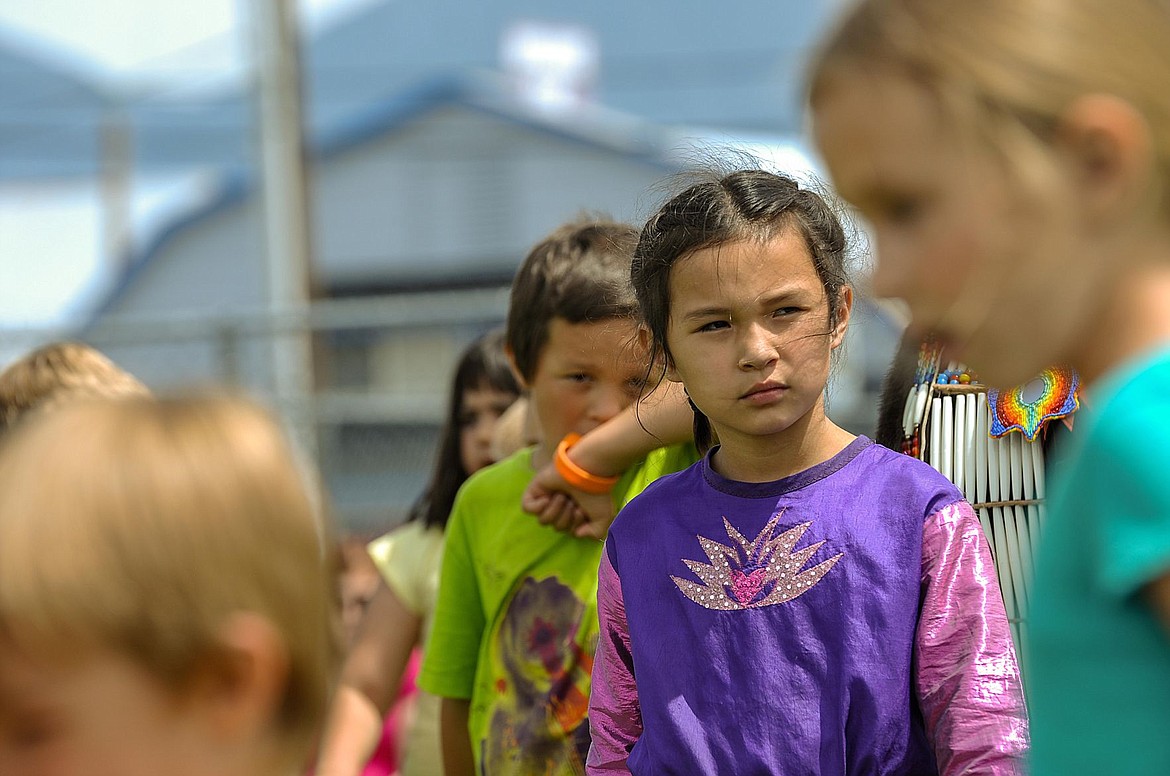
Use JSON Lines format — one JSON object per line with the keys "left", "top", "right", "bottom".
{"left": 810, "top": 0, "right": 1170, "bottom": 776}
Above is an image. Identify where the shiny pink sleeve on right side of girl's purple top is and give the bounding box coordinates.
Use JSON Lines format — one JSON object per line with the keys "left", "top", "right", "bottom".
{"left": 915, "top": 501, "right": 1028, "bottom": 776}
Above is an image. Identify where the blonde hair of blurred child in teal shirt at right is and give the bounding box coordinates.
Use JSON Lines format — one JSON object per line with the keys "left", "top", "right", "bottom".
{"left": 810, "top": 0, "right": 1170, "bottom": 210}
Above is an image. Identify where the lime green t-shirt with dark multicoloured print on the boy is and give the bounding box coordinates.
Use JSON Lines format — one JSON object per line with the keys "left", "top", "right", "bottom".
{"left": 419, "top": 445, "right": 697, "bottom": 776}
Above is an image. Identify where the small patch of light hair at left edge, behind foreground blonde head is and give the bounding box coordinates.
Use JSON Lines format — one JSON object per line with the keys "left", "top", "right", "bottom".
{"left": 0, "top": 342, "right": 150, "bottom": 432}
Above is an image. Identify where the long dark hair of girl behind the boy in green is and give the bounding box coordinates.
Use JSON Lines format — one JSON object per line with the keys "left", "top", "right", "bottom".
{"left": 407, "top": 329, "right": 519, "bottom": 529}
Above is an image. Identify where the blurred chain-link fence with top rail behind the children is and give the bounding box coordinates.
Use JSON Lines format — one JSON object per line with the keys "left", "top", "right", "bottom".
{"left": 0, "top": 287, "right": 899, "bottom": 535}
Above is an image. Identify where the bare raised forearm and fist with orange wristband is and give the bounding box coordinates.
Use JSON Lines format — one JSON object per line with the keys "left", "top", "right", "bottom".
{"left": 523, "top": 380, "right": 695, "bottom": 538}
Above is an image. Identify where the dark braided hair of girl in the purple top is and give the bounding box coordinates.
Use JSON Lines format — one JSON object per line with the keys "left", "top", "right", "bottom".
{"left": 629, "top": 170, "right": 848, "bottom": 449}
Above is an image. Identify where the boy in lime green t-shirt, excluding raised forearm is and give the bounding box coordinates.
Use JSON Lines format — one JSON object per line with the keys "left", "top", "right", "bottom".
{"left": 419, "top": 221, "right": 695, "bottom": 776}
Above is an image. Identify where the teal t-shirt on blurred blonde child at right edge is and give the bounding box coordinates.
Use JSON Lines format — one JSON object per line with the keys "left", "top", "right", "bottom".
{"left": 1025, "top": 350, "right": 1170, "bottom": 776}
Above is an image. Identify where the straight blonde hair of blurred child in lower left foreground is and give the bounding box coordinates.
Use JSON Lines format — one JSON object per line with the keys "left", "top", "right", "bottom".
{"left": 0, "top": 397, "right": 339, "bottom": 757}
